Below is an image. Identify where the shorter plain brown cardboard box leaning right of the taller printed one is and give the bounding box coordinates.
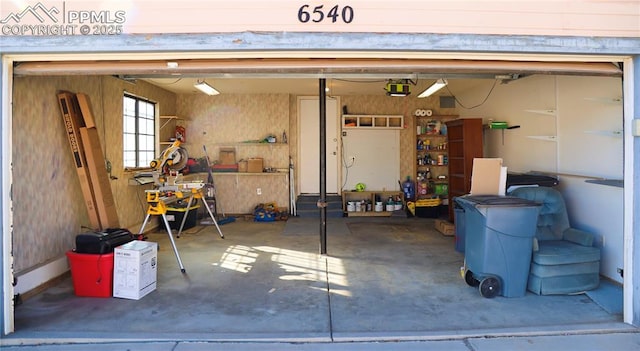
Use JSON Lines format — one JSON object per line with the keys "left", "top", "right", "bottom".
{"left": 80, "top": 128, "right": 120, "bottom": 229}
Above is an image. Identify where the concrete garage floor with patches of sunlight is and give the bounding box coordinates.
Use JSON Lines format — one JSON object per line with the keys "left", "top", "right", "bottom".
{"left": 9, "top": 218, "right": 629, "bottom": 342}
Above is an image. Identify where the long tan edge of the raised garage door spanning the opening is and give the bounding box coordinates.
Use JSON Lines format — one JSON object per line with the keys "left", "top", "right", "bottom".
{"left": 3, "top": 55, "right": 622, "bottom": 338}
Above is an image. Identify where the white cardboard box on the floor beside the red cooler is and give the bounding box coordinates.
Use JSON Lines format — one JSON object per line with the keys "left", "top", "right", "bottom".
{"left": 113, "top": 240, "right": 158, "bottom": 300}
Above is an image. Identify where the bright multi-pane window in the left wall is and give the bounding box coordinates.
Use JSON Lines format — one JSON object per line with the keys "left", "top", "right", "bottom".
{"left": 122, "top": 95, "right": 156, "bottom": 168}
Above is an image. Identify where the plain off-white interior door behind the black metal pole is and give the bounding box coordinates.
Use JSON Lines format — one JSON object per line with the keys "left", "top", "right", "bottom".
{"left": 297, "top": 97, "right": 340, "bottom": 194}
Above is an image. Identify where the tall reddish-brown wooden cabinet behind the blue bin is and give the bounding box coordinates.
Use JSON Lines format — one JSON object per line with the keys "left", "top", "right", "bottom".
{"left": 446, "top": 118, "right": 483, "bottom": 222}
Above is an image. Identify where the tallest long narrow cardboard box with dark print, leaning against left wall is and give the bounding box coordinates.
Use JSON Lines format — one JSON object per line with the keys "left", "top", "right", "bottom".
{"left": 58, "top": 92, "right": 101, "bottom": 229}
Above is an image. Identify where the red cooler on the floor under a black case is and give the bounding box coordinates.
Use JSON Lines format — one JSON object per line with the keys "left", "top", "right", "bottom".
{"left": 67, "top": 251, "right": 113, "bottom": 297}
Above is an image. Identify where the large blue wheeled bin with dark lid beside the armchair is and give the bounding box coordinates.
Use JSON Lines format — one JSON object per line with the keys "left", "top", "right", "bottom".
{"left": 454, "top": 195, "right": 540, "bottom": 298}
